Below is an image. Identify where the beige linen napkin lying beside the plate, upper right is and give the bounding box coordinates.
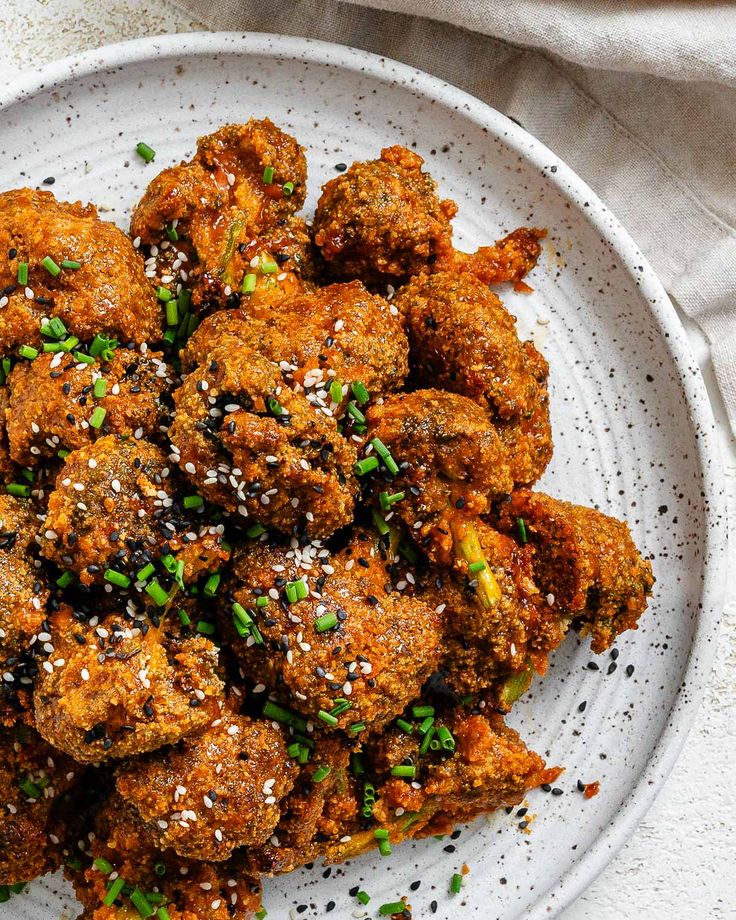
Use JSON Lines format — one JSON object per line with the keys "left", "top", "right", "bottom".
{"left": 177, "top": 0, "right": 736, "bottom": 433}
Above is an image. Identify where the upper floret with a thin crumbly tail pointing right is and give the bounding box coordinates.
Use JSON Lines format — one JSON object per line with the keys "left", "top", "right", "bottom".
{"left": 314, "top": 146, "right": 545, "bottom": 289}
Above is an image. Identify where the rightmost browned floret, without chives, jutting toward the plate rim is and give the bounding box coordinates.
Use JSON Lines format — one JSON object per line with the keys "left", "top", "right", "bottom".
{"left": 498, "top": 489, "right": 654, "bottom": 652}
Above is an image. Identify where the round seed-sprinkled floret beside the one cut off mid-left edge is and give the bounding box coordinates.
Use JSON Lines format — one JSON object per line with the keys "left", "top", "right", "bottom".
{"left": 41, "top": 434, "right": 177, "bottom": 585}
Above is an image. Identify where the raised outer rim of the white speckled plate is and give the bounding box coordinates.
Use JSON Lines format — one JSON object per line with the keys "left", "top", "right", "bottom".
{"left": 0, "top": 31, "right": 730, "bottom": 920}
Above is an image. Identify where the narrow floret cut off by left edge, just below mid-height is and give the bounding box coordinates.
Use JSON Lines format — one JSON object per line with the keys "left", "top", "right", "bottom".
{"left": 0, "top": 495, "right": 49, "bottom": 671}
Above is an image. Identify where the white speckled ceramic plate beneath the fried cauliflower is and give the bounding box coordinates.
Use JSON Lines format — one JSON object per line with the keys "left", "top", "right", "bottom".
{"left": 0, "top": 34, "right": 726, "bottom": 920}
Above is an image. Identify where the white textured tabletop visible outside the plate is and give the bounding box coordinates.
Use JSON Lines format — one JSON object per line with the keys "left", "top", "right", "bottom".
{"left": 0, "top": 0, "right": 736, "bottom": 920}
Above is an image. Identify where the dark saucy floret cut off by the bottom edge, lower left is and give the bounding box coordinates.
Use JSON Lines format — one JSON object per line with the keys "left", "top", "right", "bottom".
{"left": 71, "top": 794, "right": 261, "bottom": 920}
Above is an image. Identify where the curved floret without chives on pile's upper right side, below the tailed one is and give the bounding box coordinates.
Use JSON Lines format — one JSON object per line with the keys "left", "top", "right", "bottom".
{"left": 394, "top": 272, "right": 552, "bottom": 484}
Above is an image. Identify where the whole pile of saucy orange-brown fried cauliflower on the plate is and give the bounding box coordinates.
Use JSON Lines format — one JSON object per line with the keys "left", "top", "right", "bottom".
{"left": 0, "top": 119, "right": 653, "bottom": 920}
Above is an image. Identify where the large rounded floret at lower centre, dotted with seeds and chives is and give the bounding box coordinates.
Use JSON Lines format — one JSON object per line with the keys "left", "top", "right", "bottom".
{"left": 221, "top": 542, "right": 441, "bottom": 733}
